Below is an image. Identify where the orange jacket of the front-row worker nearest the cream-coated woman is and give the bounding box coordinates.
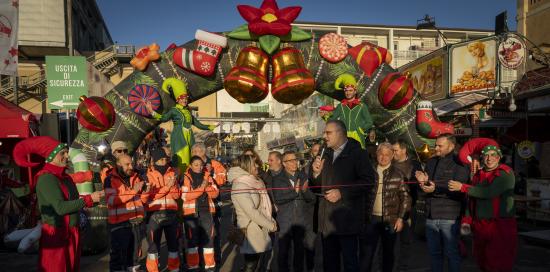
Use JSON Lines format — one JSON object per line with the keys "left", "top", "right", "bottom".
{"left": 181, "top": 169, "right": 220, "bottom": 216}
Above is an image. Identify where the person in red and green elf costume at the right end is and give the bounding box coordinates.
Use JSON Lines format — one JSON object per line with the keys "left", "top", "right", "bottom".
{"left": 449, "top": 145, "right": 518, "bottom": 272}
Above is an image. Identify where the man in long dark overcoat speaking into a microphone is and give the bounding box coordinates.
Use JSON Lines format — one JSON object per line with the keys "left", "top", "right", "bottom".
{"left": 310, "top": 120, "right": 375, "bottom": 272}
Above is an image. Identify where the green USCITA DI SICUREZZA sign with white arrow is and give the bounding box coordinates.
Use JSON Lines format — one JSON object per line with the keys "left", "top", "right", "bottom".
{"left": 46, "top": 56, "right": 88, "bottom": 109}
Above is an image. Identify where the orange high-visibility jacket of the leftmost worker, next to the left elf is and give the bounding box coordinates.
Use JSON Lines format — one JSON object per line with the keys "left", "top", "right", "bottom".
{"left": 105, "top": 169, "right": 147, "bottom": 224}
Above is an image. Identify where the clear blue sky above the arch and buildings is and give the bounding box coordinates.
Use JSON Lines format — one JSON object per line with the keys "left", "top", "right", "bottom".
{"left": 96, "top": 0, "right": 516, "bottom": 49}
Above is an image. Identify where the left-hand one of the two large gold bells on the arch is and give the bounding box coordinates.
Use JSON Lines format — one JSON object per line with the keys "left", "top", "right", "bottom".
{"left": 223, "top": 46, "right": 269, "bottom": 103}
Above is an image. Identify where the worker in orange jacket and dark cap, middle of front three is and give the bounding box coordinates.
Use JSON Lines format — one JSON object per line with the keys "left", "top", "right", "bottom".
{"left": 145, "top": 148, "right": 180, "bottom": 272}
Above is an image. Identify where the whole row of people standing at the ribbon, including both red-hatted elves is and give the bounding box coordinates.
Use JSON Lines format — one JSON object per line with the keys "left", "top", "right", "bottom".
{"left": 12, "top": 120, "right": 517, "bottom": 271}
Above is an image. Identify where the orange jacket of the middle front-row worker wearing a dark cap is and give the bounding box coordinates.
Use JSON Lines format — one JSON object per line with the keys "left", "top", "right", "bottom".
{"left": 145, "top": 167, "right": 180, "bottom": 212}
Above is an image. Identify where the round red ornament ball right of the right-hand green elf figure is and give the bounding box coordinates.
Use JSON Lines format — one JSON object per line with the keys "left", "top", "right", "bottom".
{"left": 378, "top": 72, "right": 414, "bottom": 110}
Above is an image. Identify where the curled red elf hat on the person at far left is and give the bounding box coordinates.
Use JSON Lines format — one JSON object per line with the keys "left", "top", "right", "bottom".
{"left": 13, "top": 136, "right": 67, "bottom": 167}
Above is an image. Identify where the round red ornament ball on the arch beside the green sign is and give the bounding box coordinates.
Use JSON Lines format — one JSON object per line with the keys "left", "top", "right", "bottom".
{"left": 76, "top": 96, "right": 116, "bottom": 132}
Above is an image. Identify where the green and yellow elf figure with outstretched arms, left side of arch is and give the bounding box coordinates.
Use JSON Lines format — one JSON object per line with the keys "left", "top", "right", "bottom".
{"left": 146, "top": 77, "right": 215, "bottom": 173}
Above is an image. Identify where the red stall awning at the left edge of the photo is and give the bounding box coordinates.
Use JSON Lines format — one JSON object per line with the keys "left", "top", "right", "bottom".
{"left": 0, "top": 97, "right": 36, "bottom": 138}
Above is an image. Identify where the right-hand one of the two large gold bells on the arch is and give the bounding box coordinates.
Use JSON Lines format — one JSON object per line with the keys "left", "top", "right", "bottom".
{"left": 271, "top": 47, "right": 315, "bottom": 105}
